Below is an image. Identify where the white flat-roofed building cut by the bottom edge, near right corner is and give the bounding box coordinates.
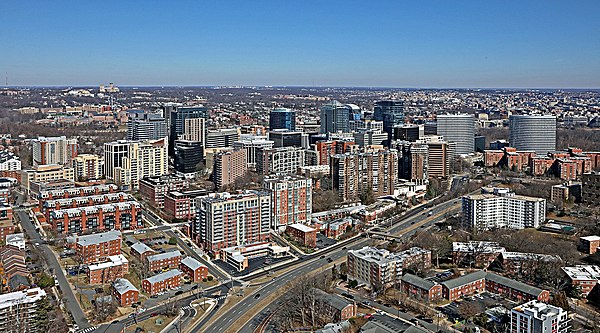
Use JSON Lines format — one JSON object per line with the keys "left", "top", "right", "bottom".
{"left": 510, "top": 300, "right": 571, "bottom": 333}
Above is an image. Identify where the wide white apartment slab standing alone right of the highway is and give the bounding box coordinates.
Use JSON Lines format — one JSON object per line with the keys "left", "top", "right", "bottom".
{"left": 462, "top": 188, "right": 546, "bottom": 230}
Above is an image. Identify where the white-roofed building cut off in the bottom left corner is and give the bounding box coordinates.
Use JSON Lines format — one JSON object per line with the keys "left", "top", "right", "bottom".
{"left": 0, "top": 288, "right": 46, "bottom": 333}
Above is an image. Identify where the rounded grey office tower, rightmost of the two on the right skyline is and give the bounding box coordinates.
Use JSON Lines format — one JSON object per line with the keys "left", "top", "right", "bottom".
{"left": 509, "top": 115, "right": 556, "bottom": 155}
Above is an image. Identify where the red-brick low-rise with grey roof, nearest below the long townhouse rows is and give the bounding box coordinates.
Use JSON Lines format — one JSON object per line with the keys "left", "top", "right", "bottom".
{"left": 75, "top": 230, "right": 121, "bottom": 264}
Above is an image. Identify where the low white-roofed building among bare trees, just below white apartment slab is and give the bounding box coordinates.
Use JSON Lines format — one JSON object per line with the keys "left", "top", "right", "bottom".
{"left": 452, "top": 241, "right": 506, "bottom": 268}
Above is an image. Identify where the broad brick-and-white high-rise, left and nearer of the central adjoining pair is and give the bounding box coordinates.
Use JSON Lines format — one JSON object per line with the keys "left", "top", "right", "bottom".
{"left": 192, "top": 191, "right": 271, "bottom": 253}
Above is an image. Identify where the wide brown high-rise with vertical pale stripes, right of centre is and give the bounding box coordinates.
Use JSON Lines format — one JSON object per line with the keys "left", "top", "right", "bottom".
{"left": 330, "top": 149, "right": 398, "bottom": 201}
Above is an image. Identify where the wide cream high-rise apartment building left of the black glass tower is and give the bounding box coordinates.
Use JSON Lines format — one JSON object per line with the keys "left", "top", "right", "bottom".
{"left": 104, "top": 138, "right": 168, "bottom": 189}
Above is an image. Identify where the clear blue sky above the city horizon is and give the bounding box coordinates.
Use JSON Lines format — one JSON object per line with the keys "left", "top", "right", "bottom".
{"left": 0, "top": 0, "right": 600, "bottom": 88}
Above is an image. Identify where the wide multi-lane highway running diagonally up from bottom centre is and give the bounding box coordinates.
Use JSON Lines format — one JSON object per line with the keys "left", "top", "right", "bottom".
{"left": 197, "top": 199, "right": 460, "bottom": 333}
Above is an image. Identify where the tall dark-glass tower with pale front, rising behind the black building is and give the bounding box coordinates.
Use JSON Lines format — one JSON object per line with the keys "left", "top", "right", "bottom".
{"left": 169, "top": 106, "right": 208, "bottom": 156}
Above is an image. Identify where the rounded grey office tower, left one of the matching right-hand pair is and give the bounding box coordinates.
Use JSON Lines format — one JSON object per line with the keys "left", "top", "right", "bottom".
{"left": 437, "top": 114, "right": 475, "bottom": 155}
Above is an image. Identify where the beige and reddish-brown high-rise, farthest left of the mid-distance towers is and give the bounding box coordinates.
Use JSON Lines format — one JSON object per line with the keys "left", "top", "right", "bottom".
{"left": 32, "top": 136, "right": 78, "bottom": 166}
